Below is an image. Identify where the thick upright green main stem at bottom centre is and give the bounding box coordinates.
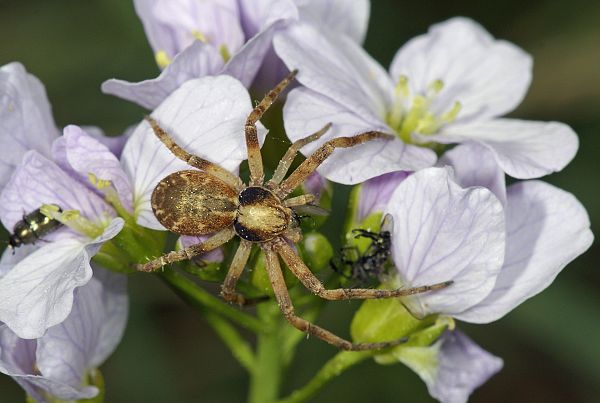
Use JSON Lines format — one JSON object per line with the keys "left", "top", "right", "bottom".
{"left": 248, "top": 302, "right": 283, "bottom": 403}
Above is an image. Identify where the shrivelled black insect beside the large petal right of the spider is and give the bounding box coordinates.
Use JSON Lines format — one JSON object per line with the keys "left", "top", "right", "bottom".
{"left": 330, "top": 214, "right": 393, "bottom": 286}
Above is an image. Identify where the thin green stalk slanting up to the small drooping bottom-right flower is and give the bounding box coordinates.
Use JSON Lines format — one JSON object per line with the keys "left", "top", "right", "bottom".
{"left": 277, "top": 351, "right": 375, "bottom": 403}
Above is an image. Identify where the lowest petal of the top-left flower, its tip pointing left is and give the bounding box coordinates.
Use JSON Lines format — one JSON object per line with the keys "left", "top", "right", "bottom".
{"left": 102, "top": 41, "right": 225, "bottom": 110}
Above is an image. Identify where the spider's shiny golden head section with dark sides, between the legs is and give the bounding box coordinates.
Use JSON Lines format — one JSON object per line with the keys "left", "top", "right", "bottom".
{"left": 234, "top": 186, "right": 292, "bottom": 242}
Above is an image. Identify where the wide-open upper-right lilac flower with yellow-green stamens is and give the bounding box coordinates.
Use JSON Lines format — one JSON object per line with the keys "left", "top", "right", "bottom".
{"left": 274, "top": 18, "right": 578, "bottom": 184}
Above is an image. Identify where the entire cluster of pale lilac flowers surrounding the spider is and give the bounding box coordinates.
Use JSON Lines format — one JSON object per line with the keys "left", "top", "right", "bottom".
{"left": 0, "top": 0, "right": 593, "bottom": 402}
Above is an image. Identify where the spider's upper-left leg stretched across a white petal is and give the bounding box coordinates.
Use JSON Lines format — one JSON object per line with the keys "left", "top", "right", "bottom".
{"left": 145, "top": 116, "right": 243, "bottom": 190}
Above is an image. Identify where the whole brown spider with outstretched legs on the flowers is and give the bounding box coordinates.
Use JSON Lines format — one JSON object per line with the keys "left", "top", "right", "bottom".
{"left": 135, "top": 71, "right": 451, "bottom": 351}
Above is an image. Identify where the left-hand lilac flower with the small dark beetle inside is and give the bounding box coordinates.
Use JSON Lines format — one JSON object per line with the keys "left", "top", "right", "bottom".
{"left": 0, "top": 126, "right": 126, "bottom": 339}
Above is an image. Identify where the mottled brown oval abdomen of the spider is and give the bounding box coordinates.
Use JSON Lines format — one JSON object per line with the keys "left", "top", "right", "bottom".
{"left": 151, "top": 170, "right": 238, "bottom": 235}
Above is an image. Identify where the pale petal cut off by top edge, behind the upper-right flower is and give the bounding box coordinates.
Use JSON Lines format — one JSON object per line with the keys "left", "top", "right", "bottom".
{"left": 296, "top": 0, "right": 371, "bottom": 44}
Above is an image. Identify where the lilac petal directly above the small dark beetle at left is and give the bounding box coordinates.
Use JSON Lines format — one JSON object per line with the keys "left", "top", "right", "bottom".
{"left": 0, "top": 150, "right": 114, "bottom": 229}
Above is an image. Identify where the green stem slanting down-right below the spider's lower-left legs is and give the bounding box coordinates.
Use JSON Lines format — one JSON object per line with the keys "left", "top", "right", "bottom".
{"left": 159, "top": 269, "right": 265, "bottom": 334}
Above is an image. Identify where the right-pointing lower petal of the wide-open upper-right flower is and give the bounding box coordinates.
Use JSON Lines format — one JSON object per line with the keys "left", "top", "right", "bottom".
{"left": 432, "top": 119, "right": 579, "bottom": 179}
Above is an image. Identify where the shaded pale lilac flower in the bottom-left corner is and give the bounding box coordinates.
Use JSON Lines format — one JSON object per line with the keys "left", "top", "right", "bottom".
{"left": 0, "top": 268, "right": 128, "bottom": 402}
